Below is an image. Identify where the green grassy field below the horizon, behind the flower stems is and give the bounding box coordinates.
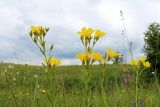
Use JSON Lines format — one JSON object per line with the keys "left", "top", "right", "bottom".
{"left": 0, "top": 64, "right": 160, "bottom": 107}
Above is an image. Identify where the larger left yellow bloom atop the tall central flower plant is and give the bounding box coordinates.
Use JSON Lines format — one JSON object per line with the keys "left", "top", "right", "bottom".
{"left": 78, "top": 27, "right": 94, "bottom": 38}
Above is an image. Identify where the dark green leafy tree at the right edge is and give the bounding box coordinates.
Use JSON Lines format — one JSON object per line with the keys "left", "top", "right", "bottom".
{"left": 144, "top": 22, "right": 160, "bottom": 77}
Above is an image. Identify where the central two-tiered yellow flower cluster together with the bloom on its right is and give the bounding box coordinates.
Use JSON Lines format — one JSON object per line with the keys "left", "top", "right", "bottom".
{"left": 76, "top": 27, "right": 120, "bottom": 66}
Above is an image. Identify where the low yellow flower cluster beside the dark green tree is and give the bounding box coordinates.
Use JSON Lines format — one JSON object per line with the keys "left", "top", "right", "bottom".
{"left": 129, "top": 56, "right": 151, "bottom": 68}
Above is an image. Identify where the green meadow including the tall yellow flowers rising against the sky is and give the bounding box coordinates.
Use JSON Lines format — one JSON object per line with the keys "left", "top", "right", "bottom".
{"left": 0, "top": 13, "right": 160, "bottom": 107}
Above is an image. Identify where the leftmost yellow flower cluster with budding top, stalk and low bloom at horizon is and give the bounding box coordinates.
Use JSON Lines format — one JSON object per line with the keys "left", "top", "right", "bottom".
{"left": 29, "top": 26, "right": 61, "bottom": 67}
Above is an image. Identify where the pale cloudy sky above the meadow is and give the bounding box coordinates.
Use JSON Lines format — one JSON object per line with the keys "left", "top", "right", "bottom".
{"left": 0, "top": 0, "right": 160, "bottom": 65}
